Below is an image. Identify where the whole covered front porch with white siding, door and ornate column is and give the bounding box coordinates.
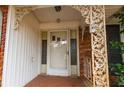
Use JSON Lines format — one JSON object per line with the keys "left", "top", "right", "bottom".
{"left": 1, "top": 5, "right": 123, "bottom": 87}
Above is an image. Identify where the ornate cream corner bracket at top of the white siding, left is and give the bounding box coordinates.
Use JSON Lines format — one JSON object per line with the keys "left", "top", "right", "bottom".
{"left": 14, "top": 7, "right": 33, "bottom": 30}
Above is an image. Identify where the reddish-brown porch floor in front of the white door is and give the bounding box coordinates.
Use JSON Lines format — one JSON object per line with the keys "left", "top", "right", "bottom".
{"left": 25, "top": 75, "right": 84, "bottom": 87}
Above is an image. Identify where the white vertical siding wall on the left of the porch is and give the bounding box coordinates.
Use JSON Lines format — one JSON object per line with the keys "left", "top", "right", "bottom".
{"left": 3, "top": 9, "right": 40, "bottom": 86}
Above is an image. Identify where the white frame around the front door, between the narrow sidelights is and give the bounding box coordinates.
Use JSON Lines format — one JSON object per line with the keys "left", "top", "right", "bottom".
{"left": 46, "top": 29, "right": 71, "bottom": 76}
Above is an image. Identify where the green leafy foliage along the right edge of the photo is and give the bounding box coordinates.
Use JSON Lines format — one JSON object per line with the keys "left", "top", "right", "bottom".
{"left": 110, "top": 10, "right": 124, "bottom": 86}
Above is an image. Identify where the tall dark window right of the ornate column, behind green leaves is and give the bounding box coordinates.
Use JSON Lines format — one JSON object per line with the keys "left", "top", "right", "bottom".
{"left": 106, "top": 24, "right": 122, "bottom": 63}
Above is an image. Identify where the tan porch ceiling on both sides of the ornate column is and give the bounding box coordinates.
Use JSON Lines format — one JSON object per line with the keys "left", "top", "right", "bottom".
{"left": 33, "top": 5, "right": 122, "bottom": 23}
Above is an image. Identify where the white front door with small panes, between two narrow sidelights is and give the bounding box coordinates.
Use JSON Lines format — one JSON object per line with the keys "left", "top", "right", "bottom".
{"left": 47, "top": 31, "right": 69, "bottom": 76}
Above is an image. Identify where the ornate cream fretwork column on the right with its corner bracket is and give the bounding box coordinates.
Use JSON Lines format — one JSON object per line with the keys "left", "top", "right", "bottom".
{"left": 73, "top": 5, "right": 109, "bottom": 87}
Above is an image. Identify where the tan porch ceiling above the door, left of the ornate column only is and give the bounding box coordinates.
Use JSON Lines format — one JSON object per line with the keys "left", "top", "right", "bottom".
{"left": 34, "top": 6, "right": 82, "bottom": 23}
